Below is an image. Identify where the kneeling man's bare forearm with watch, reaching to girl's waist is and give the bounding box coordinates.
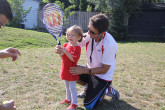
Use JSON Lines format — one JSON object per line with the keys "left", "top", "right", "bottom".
{"left": 70, "top": 64, "right": 111, "bottom": 75}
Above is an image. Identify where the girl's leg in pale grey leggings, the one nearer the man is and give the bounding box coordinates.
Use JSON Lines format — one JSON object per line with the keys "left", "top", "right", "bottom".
{"left": 69, "top": 81, "right": 77, "bottom": 105}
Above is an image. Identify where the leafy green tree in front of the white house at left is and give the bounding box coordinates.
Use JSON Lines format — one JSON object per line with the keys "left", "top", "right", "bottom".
{"left": 8, "top": 0, "right": 31, "bottom": 28}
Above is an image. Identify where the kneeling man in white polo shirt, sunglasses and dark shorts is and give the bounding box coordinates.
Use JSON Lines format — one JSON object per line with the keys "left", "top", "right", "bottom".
{"left": 70, "top": 14, "right": 119, "bottom": 110}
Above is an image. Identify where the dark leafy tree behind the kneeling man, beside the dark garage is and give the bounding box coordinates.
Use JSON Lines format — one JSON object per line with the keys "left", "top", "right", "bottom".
{"left": 88, "top": 0, "right": 141, "bottom": 39}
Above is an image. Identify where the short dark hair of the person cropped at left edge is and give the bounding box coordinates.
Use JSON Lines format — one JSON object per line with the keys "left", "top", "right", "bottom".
{"left": 0, "top": 0, "right": 13, "bottom": 21}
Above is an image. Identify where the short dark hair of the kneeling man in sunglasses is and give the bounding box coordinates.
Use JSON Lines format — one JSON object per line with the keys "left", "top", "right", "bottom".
{"left": 89, "top": 13, "right": 109, "bottom": 33}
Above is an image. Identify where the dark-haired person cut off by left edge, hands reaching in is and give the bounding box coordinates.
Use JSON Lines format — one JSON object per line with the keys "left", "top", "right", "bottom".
{"left": 0, "top": 0, "right": 21, "bottom": 110}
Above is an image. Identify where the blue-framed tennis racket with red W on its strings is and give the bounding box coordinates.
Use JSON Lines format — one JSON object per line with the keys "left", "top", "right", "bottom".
{"left": 42, "top": 3, "right": 64, "bottom": 45}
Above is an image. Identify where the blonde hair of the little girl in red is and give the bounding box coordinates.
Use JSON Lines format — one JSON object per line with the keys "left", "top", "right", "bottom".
{"left": 66, "top": 25, "right": 83, "bottom": 42}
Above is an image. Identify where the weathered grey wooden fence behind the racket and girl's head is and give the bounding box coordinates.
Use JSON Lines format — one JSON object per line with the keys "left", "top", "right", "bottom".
{"left": 38, "top": 11, "right": 100, "bottom": 30}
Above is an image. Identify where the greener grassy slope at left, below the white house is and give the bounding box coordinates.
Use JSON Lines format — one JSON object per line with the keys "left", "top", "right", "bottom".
{"left": 0, "top": 27, "right": 65, "bottom": 49}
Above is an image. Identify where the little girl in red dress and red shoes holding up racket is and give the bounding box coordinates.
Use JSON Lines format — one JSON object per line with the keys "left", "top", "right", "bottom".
{"left": 55, "top": 25, "right": 83, "bottom": 110}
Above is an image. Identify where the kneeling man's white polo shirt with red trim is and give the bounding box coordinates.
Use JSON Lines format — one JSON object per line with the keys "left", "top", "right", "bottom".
{"left": 78, "top": 32, "right": 118, "bottom": 81}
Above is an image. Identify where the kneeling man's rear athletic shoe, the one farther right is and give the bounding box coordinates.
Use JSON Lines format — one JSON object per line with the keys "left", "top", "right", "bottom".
{"left": 106, "top": 85, "right": 120, "bottom": 100}
